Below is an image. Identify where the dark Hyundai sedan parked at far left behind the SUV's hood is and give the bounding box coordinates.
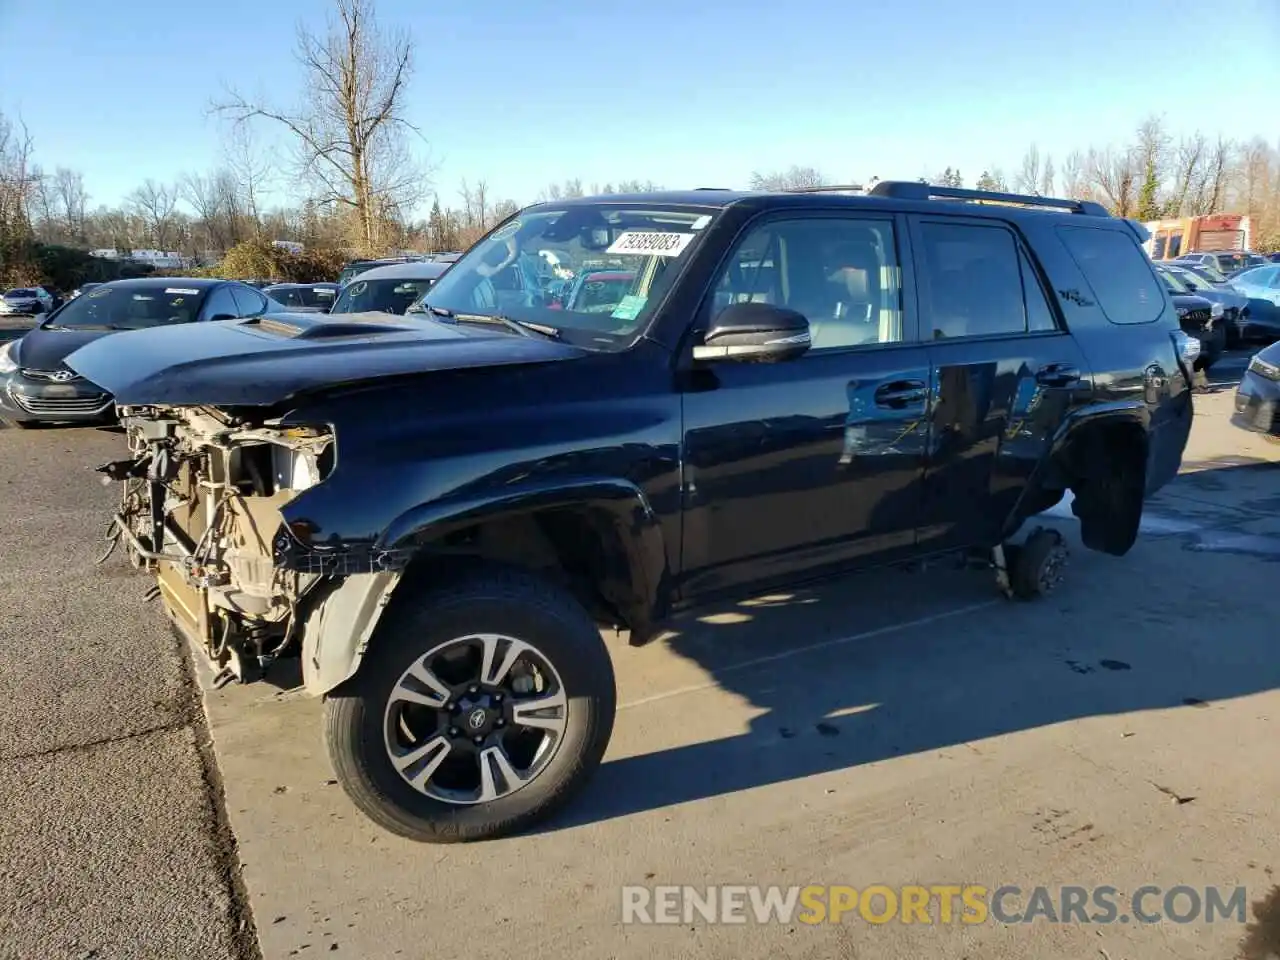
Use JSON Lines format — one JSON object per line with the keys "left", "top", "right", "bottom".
{"left": 0, "top": 276, "right": 280, "bottom": 426}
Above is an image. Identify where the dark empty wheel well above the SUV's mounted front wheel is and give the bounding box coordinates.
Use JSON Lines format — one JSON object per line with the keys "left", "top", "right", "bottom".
{"left": 397, "top": 508, "right": 635, "bottom": 628}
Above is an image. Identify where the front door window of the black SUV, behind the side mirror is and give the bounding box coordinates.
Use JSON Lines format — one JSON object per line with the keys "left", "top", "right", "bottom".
{"left": 712, "top": 216, "right": 904, "bottom": 349}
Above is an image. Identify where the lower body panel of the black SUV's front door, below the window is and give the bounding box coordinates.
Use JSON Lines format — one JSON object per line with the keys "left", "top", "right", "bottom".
{"left": 682, "top": 346, "right": 929, "bottom": 595}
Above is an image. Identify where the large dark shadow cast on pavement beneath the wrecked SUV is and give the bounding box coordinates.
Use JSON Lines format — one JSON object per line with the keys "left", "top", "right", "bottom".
{"left": 543, "top": 465, "right": 1280, "bottom": 831}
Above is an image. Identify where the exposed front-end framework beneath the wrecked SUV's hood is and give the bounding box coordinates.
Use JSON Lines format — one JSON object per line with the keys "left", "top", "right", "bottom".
{"left": 99, "top": 407, "right": 334, "bottom": 686}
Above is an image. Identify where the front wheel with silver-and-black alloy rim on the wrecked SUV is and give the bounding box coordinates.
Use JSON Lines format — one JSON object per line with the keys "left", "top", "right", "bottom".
{"left": 325, "top": 570, "right": 617, "bottom": 844}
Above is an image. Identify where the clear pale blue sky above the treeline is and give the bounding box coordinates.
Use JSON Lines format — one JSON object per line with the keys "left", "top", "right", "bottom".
{"left": 0, "top": 0, "right": 1280, "bottom": 217}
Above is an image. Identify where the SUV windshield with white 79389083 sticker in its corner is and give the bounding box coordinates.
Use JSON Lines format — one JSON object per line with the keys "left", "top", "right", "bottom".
{"left": 426, "top": 201, "right": 717, "bottom": 348}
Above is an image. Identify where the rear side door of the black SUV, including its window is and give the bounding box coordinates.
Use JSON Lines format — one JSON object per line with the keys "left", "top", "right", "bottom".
{"left": 911, "top": 215, "right": 1092, "bottom": 550}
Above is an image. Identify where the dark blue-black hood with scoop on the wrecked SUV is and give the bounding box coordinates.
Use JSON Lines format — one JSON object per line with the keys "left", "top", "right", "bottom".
{"left": 67, "top": 314, "right": 586, "bottom": 407}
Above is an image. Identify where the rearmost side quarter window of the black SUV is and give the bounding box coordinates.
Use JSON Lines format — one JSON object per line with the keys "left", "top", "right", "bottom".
{"left": 1057, "top": 227, "right": 1165, "bottom": 324}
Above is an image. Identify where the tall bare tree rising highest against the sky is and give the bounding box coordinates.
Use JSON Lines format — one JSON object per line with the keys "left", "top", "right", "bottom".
{"left": 215, "top": 0, "right": 426, "bottom": 251}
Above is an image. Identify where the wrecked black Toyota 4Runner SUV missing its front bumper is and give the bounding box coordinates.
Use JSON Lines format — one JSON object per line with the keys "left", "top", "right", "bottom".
{"left": 68, "top": 183, "right": 1197, "bottom": 842}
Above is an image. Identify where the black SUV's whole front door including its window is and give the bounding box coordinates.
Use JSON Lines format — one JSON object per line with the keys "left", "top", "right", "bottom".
{"left": 681, "top": 212, "right": 929, "bottom": 599}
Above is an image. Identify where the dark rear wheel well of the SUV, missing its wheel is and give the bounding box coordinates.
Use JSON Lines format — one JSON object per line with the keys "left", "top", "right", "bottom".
{"left": 1055, "top": 420, "right": 1148, "bottom": 557}
